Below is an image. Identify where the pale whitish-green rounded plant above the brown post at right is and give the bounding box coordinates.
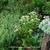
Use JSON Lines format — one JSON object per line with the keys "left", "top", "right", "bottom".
{"left": 39, "top": 18, "right": 50, "bottom": 34}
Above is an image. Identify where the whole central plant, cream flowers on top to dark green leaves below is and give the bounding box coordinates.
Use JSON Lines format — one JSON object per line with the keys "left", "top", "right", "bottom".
{"left": 14, "top": 11, "right": 40, "bottom": 46}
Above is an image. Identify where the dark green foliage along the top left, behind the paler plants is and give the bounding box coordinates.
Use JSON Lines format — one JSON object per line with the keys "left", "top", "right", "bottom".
{"left": 0, "top": 0, "right": 33, "bottom": 14}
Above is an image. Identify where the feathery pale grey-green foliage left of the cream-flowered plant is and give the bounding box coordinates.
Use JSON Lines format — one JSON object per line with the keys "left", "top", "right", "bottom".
{"left": 0, "top": 11, "right": 18, "bottom": 47}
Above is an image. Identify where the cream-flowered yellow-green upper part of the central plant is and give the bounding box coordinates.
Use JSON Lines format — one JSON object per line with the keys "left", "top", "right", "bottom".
{"left": 14, "top": 12, "right": 40, "bottom": 33}
